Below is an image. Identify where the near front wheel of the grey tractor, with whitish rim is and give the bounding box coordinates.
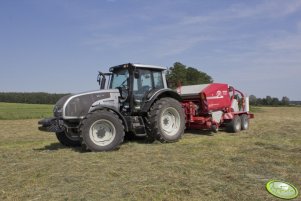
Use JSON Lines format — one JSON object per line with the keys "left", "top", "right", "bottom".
{"left": 80, "top": 110, "right": 125, "bottom": 151}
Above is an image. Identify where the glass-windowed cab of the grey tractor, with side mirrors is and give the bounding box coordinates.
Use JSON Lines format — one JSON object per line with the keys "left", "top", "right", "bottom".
{"left": 98, "top": 63, "right": 167, "bottom": 114}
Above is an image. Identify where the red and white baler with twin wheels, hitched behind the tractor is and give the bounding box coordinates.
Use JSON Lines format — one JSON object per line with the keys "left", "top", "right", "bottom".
{"left": 177, "top": 83, "right": 254, "bottom": 132}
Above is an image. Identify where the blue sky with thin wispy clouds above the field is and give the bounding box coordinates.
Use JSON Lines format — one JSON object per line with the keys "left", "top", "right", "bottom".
{"left": 0, "top": 0, "right": 301, "bottom": 100}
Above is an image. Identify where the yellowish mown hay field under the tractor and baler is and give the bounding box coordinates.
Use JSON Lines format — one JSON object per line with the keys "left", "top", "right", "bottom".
{"left": 0, "top": 103, "right": 301, "bottom": 201}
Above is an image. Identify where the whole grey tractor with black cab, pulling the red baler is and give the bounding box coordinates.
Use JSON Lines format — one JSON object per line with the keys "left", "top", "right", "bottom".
{"left": 39, "top": 63, "right": 186, "bottom": 151}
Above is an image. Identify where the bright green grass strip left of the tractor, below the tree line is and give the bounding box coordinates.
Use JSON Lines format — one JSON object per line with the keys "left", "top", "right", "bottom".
{"left": 0, "top": 102, "right": 53, "bottom": 120}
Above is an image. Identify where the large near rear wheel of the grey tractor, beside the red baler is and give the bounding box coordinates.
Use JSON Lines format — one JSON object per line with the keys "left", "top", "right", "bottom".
{"left": 145, "top": 98, "right": 185, "bottom": 142}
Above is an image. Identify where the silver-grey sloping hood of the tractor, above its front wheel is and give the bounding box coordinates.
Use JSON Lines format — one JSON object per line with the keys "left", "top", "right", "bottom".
{"left": 53, "top": 89, "right": 119, "bottom": 119}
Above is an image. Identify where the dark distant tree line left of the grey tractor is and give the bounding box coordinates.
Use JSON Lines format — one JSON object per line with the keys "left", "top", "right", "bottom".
{"left": 0, "top": 92, "right": 67, "bottom": 104}
